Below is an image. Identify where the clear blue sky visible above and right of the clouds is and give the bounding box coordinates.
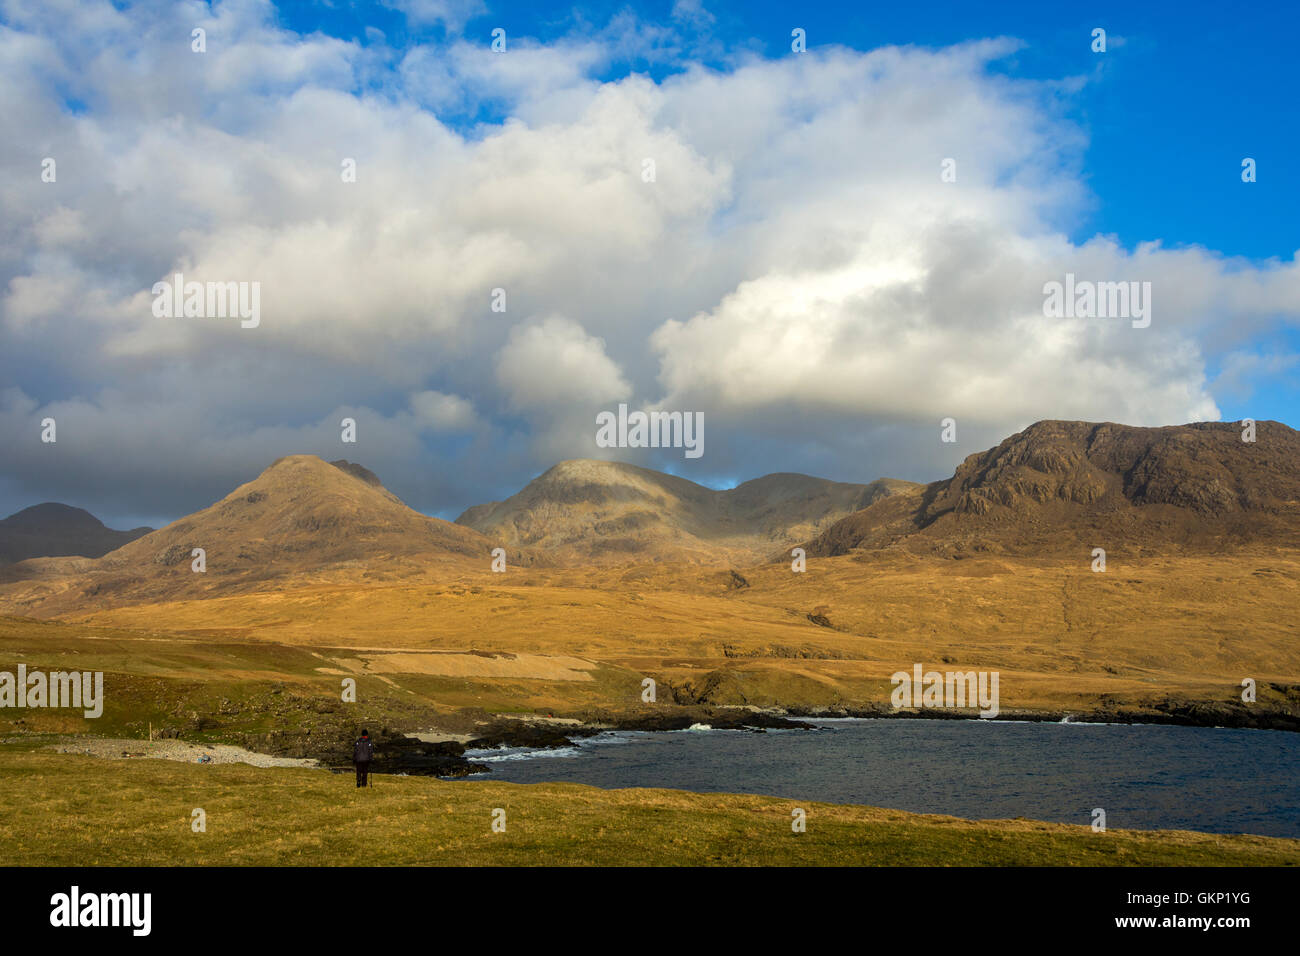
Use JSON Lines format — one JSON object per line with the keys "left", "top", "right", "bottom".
{"left": 271, "top": 0, "right": 1300, "bottom": 425}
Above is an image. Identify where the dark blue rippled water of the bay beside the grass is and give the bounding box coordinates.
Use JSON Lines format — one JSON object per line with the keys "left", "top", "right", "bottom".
{"left": 454, "top": 719, "right": 1300, "bottom": 836}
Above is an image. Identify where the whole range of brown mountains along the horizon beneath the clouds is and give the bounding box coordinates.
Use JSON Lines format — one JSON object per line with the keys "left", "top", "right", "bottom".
{"left": 0, "top": 421, "right": 1300, "bottom": 614}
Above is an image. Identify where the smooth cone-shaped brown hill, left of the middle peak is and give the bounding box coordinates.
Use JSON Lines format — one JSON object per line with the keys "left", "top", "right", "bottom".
{"left": 0, "top": 455, "right": 509, "bottom": 614}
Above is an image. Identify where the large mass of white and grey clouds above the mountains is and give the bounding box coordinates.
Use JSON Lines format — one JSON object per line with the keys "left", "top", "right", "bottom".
{"left": 0, "top": 1, "right": 1300, "bottom": 522}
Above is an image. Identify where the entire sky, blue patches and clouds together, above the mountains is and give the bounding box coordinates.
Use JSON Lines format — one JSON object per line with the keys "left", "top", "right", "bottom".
{"left": 0, "top": 0, "right": 1300, "bottom": 527}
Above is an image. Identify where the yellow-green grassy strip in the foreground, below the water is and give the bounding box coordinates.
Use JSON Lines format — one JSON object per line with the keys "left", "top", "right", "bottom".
{"left": 0, "top": 743, "right": 1300, "bottom": 866}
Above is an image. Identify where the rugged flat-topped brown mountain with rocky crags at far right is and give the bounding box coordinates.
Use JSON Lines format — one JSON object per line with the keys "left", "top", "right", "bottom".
{"left": 809, "top": 421, "right": 1300, "bottom": 557}
